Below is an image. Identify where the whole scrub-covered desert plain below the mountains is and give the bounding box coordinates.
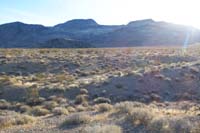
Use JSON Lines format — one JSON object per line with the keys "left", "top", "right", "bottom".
{"left": 0, "top": 45, "right": 200, "bottom": 133}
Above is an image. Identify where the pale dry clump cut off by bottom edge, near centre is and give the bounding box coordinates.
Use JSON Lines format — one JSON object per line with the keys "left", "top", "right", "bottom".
{"left": 81, "top": 124, "right": 123, "bottom": 133}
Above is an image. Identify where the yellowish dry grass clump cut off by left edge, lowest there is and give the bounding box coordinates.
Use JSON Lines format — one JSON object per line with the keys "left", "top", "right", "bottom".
{"left": 0, "top": 115, "right": 36, "bottom": 129}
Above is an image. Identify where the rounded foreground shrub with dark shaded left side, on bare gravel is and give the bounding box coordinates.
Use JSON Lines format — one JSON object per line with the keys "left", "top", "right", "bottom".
{"left": 63, "top": 114, "right": 91, "bottom": 125}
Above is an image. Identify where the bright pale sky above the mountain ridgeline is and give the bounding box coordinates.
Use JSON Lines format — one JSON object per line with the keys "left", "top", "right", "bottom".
{"left": 0, "top": 0, "right": 200, "bottom": 28}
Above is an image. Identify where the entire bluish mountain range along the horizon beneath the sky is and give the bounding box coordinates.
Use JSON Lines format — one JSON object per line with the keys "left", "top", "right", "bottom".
{"left": 0, "top": 19, "right": 200, "bottom": 48}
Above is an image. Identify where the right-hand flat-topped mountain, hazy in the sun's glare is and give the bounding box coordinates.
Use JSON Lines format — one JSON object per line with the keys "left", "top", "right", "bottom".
{"left": 92, "top": 20, "right": 200, "bottom": 47}
